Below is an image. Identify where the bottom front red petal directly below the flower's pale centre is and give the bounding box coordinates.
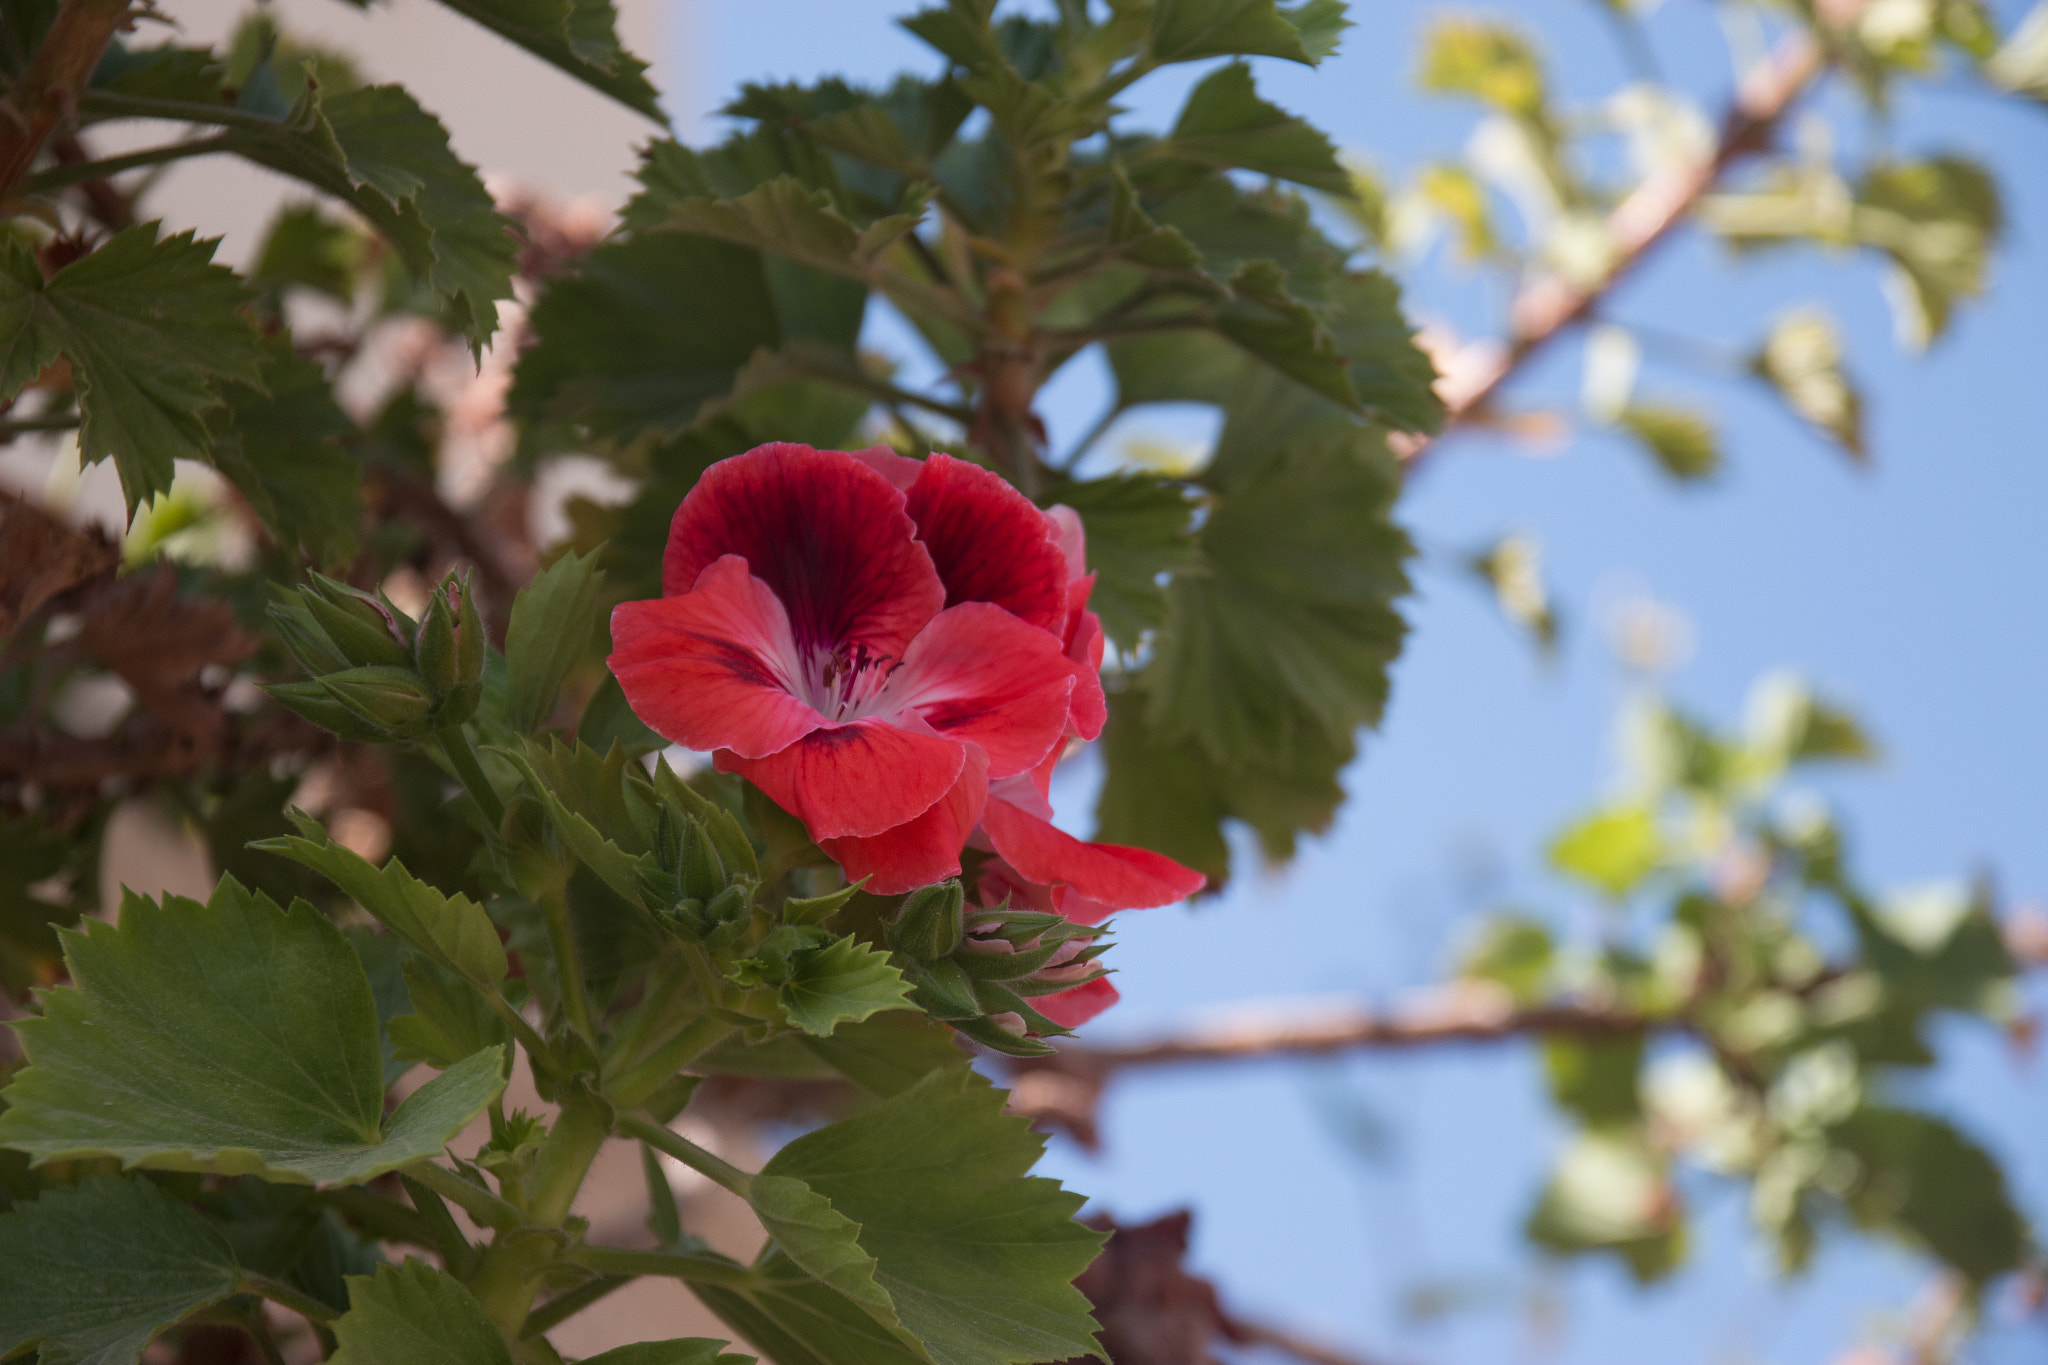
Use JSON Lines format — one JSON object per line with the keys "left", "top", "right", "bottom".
{"left": 717, "top": 720, "right": 973, "bottom": 841}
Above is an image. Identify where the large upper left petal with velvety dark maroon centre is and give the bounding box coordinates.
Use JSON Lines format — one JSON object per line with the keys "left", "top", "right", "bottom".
{"left": 662, "top": 442, "right": 946, "bottom": 657}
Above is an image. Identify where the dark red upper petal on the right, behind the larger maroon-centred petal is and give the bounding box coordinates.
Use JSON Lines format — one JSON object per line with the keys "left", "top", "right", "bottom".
{"left": 909, "top": 454, "right": 1067, "bottom": 634}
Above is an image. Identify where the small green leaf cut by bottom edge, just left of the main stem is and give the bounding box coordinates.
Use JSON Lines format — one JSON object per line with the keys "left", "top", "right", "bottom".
{"left": 328, "top": 1259, "right": 512, "bottom": 1365}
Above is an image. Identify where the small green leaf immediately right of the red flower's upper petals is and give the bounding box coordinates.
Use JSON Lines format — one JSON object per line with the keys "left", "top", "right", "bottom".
{"left": 1053, "top": 475, "right": 1200, "bottom": 653}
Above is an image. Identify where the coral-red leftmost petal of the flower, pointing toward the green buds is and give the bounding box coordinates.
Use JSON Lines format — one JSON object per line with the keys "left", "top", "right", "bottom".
{"left": 606, "top": 555, "right": 825, "bottom": 757}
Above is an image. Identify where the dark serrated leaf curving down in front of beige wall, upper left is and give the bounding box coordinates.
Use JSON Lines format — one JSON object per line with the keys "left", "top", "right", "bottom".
{"left": 236, "top": 86, "right": 518, "bottom": 350}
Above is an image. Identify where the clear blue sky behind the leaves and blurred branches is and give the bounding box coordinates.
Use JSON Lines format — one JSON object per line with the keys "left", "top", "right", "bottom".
{"left": 666, "top": 0, "right": 2048, "bottom": 1365}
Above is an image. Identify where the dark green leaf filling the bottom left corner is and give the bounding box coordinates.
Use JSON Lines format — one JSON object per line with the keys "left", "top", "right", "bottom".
{"left": 0, "top": 1175, "right": 240, "bottom": 1365}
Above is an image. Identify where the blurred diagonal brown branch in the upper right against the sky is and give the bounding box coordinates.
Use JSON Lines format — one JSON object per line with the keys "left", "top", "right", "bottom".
{"left": 1405, "top": 0, "right": 1864, "bottom": 473}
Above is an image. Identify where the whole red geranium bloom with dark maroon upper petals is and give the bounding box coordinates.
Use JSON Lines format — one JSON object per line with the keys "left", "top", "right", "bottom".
{"left": 610, "top": 444, "right": 1202, "bottom": 1023}
